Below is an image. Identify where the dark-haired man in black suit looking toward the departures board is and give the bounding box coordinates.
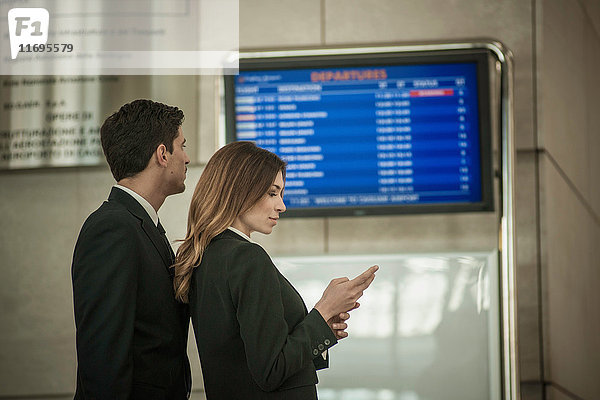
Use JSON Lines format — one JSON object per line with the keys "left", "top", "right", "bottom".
{"left": 71, "top": 100, "right": 191, "bottom": 400}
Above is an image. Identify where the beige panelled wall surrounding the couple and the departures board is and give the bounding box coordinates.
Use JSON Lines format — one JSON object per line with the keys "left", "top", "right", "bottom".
{"left": 0, "top": 0, "right": 600, "bottom": 400}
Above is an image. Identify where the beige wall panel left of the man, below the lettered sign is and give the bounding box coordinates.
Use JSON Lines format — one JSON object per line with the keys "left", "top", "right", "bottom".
{"left": 0, "top": 170, "right": 80, "bottom": 396}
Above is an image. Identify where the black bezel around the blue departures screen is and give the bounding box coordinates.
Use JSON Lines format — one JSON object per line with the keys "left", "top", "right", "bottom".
{"left": 224, "top": 49, "right": 494, "bottom": 217}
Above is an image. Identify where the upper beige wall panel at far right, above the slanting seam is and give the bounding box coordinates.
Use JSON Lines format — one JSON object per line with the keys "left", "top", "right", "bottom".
{"left": 538, "top": 1, "right": 590, "bottom": 199}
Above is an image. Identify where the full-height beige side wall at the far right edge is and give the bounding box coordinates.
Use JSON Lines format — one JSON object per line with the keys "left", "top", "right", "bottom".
{"left": 537, "top": 0, "right": 600, "bottom": 400}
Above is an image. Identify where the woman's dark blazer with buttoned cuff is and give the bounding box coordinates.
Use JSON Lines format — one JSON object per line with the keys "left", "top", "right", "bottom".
{"left": 189, "top": 230, "right": 337, "bottom": 400}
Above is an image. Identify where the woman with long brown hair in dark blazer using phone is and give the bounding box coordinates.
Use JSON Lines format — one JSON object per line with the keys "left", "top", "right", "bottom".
{"left": 175, "top": 142, "right": 377, "bottom": 399}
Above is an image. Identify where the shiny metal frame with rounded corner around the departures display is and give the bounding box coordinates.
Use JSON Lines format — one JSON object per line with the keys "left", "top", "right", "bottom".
{"left": 219, "top": 39, "right": 521, "bottom": 400}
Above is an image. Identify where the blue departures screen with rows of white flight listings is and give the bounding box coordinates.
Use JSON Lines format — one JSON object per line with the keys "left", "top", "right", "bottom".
{"left": 234, "top": 62, "right": 482, "bottom": 209}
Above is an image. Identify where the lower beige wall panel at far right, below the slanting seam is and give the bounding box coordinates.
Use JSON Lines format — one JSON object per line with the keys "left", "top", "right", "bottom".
{"left": 540, "top": 155, "right": 600, "bottom": 399}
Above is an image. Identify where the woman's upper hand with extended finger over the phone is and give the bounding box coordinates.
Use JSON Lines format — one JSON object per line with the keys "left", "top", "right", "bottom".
{"left": 315, "top": 265, "right": 379, "bottom": 322}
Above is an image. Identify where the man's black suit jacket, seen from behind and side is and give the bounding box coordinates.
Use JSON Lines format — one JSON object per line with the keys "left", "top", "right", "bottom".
{"left": 71, "top": 188, "right": 191, "bottom": 400}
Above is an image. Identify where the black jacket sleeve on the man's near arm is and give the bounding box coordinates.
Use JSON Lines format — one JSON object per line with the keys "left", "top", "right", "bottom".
{"left": 71, "top": 215, "right": 138, "bottom": 399}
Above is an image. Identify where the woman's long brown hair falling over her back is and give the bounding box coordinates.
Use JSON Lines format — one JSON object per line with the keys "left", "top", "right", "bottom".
{"left": 173, "top": 142, "right": 285, "bottom": 303}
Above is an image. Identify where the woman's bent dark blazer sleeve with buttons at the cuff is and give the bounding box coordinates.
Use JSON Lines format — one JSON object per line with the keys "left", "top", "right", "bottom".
{"left": 228, "top": 244, "right": 337, "bottom": 391}
